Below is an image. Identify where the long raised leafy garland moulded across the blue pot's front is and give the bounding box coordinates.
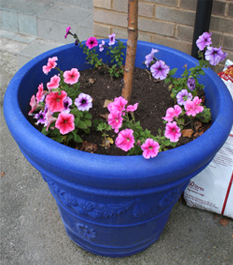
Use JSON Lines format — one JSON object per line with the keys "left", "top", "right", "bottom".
{"left": 47, "top": 178, "right": 150, "bottom": 218}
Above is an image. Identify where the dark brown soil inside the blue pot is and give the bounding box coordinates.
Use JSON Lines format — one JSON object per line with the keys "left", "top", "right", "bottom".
{"left": 29, "top": 68, "right": 210, "bottom": 155}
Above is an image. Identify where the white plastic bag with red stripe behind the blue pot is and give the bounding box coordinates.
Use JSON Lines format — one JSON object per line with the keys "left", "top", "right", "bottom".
{"left": 184, "top": 60, "right": 233, "bottom": 218}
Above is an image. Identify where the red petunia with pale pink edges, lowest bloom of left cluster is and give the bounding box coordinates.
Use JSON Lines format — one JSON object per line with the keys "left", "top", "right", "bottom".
{"left": 55, "top": 112, "right": 75, "bottom": 135}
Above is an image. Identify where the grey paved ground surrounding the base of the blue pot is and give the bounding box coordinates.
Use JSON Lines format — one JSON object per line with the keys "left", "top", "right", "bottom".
{"left": 0, "top": 6, "right": 233, "bottom": 265}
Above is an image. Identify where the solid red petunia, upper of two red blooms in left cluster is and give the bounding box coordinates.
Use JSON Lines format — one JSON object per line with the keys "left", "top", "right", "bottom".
{"left": 45, "top": 90, "right": 67, "bottom": 112}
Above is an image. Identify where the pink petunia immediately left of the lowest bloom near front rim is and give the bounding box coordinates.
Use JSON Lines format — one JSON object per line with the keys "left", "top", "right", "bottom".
{"left": 115, "top": 129, "right": 135, "bottom": 152}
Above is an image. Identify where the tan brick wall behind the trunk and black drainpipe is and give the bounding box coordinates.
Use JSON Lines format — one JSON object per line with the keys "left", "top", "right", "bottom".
{"left": 93, "top": 0, "right": 233, "bottom": 69}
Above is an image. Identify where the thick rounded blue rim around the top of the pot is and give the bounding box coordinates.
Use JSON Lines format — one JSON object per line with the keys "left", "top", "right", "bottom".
{"left": 4, "top": 40, "right": 233, "bottom": 188}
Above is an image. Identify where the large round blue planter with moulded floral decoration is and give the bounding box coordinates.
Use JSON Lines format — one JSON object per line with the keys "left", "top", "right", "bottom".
{"left": 4, "top": 41, "right": 233, "bottom": 257}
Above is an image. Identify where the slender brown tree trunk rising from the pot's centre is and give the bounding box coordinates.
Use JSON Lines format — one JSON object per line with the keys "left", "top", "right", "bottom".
{"left": 122, "top": 0, "right": 138, "bottom": 102}
